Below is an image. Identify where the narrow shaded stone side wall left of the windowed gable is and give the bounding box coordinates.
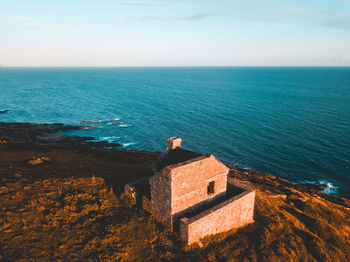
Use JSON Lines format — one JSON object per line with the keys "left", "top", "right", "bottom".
{"left": 149, "top": 168, "right": 171, "bottom": 225}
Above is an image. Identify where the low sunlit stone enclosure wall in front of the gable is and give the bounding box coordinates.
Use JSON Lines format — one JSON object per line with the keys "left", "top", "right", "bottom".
{"left": 180, "top": 191, "right": 255, "bottom": 244}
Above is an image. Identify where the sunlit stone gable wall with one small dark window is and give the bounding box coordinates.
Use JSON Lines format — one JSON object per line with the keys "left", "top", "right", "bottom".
{"left": 170, "top": 155, "right": 228, "bottom": 215}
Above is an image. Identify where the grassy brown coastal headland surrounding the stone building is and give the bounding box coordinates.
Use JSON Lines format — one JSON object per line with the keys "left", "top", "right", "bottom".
{"left": 0, "top": 123, "right": 350, "bottom": 261}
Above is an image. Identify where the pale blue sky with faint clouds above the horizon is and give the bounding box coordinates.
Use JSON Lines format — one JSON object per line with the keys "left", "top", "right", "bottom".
{"left": 0, "top": 0, "right": 350, "bottom": 66}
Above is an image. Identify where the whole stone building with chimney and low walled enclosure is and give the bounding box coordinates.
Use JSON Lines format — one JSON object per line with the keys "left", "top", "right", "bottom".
{"left": 125, "top": 137, "right": 255, "bottom": 244}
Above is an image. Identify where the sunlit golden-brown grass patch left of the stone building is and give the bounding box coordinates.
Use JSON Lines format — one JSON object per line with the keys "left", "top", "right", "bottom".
{"left": 0, "top": 177, "right": 175, "bottom": 261}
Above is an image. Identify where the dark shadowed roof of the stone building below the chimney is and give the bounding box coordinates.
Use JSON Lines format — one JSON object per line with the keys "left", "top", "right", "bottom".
{"left": 153, "top": 147, "right": 203, "bottom": 172}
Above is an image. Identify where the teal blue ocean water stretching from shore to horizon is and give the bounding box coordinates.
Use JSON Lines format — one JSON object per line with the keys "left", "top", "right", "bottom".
{"left": 0, "top": 67, "right": 350, "bottom": 197}
